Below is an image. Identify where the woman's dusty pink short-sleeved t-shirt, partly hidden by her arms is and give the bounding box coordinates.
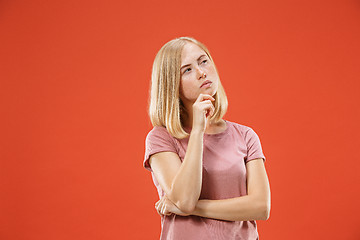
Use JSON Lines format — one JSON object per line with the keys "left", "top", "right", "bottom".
{"left": 143, "top": 120, "right": 265, "bottom": 240}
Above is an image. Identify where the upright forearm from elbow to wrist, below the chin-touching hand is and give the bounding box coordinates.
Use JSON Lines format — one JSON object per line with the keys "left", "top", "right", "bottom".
{"left": 168, "top": 130, "right": 204, "bottom": 212}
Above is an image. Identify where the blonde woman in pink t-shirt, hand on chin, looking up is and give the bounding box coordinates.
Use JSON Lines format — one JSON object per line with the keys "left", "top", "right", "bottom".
{"left": 144, "top": 37, "right": 270, "bottom": 240}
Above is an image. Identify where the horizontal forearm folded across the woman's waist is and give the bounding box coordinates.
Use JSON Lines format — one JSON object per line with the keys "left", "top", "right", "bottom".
{"left": 192, "top": 195, "right": 270, "bottom": 221}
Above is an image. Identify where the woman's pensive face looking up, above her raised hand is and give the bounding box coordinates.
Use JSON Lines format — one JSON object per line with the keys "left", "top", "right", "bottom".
{"left": 180, "top": 42, "right": 219, "bottom": 102}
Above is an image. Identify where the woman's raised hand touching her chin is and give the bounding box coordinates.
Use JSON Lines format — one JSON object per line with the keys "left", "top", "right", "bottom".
{"left": 192, "top": 93, "right": 215, "bottom": 132}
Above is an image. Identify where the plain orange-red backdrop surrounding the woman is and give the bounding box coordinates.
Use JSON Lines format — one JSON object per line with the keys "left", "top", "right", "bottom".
{"left": 0, "top": 0, "right": 360, "bottom": 240}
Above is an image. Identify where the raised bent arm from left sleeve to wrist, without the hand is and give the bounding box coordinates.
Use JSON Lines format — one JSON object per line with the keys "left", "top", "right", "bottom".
{"left": 149, "top": 129, "right": 204, "bottom": 213}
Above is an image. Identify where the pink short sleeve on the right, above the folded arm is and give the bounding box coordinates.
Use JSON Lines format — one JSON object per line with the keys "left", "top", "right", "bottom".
{"left": 245, "top": 127, "right": 266, "bottom": 163}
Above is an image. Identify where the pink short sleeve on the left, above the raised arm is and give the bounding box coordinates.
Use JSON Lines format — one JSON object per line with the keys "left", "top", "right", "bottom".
{"left": 143, "top": 126, "right": 177, "bottom": 171}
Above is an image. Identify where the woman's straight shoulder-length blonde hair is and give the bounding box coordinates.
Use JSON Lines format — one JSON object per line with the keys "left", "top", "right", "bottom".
{"left": 148, "top": 37, "right": 228, "bottom": 139}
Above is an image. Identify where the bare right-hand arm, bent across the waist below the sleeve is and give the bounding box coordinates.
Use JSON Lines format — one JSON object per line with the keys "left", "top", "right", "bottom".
{"left": 191, "top": 158, "right": 270, "bottom": 221}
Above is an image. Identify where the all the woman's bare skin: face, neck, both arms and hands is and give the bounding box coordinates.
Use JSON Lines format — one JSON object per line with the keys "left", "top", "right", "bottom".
{"left": 149, "top": 43, "right": 270, "bottom": 221}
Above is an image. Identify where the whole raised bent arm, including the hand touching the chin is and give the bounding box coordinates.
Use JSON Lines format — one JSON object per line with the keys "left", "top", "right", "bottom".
{"left": 149, "top": 94, "right": 215, "bottom": 213}
